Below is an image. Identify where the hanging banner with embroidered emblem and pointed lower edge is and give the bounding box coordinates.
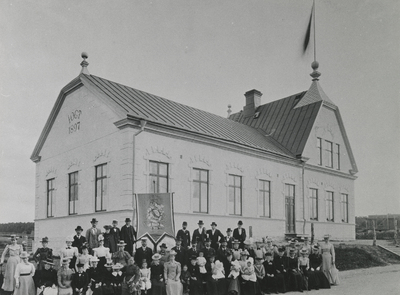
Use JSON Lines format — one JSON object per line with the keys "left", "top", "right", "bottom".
{"left": 136, "top": 193, "right": 175, "bottom": 243}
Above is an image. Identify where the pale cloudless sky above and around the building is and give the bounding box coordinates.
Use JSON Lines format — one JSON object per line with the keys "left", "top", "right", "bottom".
{"left": 0, "top": 0, "right": 400, "bottom": 223}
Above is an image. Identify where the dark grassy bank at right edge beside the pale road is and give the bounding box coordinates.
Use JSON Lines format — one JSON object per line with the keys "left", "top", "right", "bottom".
{"left": 335, "top": 244, "right": 400, "bottom": 270}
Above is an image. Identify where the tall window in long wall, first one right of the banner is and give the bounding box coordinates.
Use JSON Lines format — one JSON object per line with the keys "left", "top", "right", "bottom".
{"left": 193, "top": 168, "right": 209, "bottom": 213}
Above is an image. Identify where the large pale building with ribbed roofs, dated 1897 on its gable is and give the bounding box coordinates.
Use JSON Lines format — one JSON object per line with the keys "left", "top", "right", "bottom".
{"left": 31, "top": 56, "right": 357, "bottom": 248}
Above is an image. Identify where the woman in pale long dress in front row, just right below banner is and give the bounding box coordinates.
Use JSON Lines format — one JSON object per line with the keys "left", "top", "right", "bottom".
{"left": 164, "top": 250, "right": 183, "bottom": 295}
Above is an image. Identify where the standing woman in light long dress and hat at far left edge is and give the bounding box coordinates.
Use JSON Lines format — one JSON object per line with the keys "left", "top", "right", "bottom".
{"left": 0, "top": 235, "right": 23, "bottom": 292}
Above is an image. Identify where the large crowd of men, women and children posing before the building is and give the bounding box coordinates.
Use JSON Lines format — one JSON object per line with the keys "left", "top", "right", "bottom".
{"left": 1, "top": 218, "right": 335, "bottom": 295}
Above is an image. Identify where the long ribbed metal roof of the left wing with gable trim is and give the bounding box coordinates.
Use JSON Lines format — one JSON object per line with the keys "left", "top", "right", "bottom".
{"left": 31, "top": 73, "right": 294, "bottom": 161}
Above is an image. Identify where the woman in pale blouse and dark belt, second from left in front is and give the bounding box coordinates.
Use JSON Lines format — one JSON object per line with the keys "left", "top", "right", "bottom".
{"left": 14, "top": 251, "right": 36, "bottom": 295}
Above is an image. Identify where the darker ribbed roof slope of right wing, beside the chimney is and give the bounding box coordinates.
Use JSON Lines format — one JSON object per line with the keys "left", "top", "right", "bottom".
{"left": 229, "top": 92, "right": 322, "bottom": 155}
